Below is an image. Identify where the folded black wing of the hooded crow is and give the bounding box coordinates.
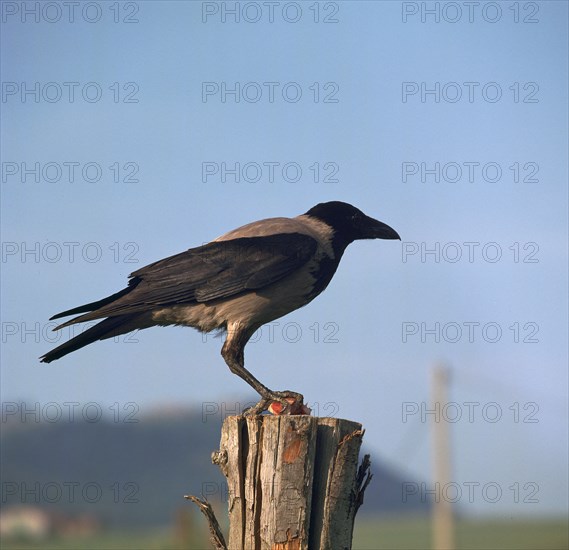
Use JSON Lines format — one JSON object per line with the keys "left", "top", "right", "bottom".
{"left": 52, "top": 233, "right": 318, "bottom": 327}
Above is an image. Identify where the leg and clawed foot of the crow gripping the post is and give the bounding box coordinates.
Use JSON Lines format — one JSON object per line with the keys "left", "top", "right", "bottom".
{"left": 221, "top": 323, "right": 304, "bottom": 416}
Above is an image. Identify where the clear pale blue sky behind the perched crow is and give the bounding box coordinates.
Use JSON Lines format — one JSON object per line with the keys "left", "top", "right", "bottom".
{"left": 0, "top": 1, "right": 568, "bottom": 515}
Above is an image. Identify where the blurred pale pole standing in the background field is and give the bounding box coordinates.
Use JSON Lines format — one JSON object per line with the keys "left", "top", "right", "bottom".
{"left": 431, "top": 365, "right": 455, "bottom": 550}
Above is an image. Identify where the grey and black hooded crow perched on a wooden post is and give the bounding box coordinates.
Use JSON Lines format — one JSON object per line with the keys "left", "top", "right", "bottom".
{"left": 40, "top": 201, "right": 400, "bottom": 414}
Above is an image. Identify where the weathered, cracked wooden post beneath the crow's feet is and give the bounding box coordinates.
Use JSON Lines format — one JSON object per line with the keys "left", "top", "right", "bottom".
{"left": 197, "top": 415, "right": 371, "bottom": 550}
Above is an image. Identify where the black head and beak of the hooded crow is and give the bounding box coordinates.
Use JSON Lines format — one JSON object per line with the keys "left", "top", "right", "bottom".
{"left": 306, "top": 201, "right": 401, "bottom": 246}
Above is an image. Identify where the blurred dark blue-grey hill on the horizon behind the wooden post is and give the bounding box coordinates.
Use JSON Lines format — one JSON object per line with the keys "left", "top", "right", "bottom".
{"left": 0, "top": 410, "right": 428, "bottom": 529}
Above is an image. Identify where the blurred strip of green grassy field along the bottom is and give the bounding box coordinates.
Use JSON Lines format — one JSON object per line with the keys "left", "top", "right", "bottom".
{"left": 1, "top": 518, "right": 569, "bottom": 550}
